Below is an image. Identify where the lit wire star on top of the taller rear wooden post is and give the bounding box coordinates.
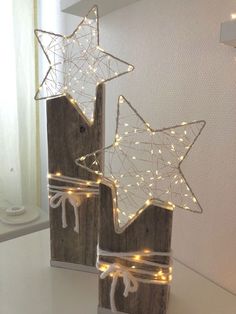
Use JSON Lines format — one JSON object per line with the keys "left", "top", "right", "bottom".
{"left": 35, "top": 6, "right": 134, "bottom": 125}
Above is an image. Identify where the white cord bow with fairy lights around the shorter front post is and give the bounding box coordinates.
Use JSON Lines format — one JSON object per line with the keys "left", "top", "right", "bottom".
{"left": 96, "top": 247, "right": 172, "bottom": 313}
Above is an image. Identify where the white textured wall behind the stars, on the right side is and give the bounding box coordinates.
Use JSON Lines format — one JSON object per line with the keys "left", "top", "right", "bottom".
{"left": 64, "top": 0, "right": 236, "bottom": 293}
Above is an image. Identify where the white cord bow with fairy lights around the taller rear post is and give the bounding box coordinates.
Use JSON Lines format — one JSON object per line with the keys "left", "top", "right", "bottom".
{"left": 48, "top": 172, "right": 99, "bottom": 233}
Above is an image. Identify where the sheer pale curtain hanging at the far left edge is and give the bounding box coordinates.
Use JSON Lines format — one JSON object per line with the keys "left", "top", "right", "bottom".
{"left": 0, "top": 0, "right": 39, "bottom": 206}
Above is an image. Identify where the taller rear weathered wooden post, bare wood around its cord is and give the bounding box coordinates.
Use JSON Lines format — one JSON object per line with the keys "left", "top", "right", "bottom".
{"left": 47, "top": 85, "right": 105, "bottom": 266}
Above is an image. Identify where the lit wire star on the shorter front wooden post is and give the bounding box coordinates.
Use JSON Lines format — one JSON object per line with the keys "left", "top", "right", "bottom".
{"left": 76, "top": 96, "right": 206, "bottom": 232}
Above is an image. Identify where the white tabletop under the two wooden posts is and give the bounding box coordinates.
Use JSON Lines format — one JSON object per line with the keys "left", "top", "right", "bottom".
{"left": 0, "top": 230, "right": 236, "bottom": 314}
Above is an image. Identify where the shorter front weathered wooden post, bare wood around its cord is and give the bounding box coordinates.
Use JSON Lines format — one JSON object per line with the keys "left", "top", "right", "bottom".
{"left": 99, "top": 185, "right": 173, "bottom": 314}
